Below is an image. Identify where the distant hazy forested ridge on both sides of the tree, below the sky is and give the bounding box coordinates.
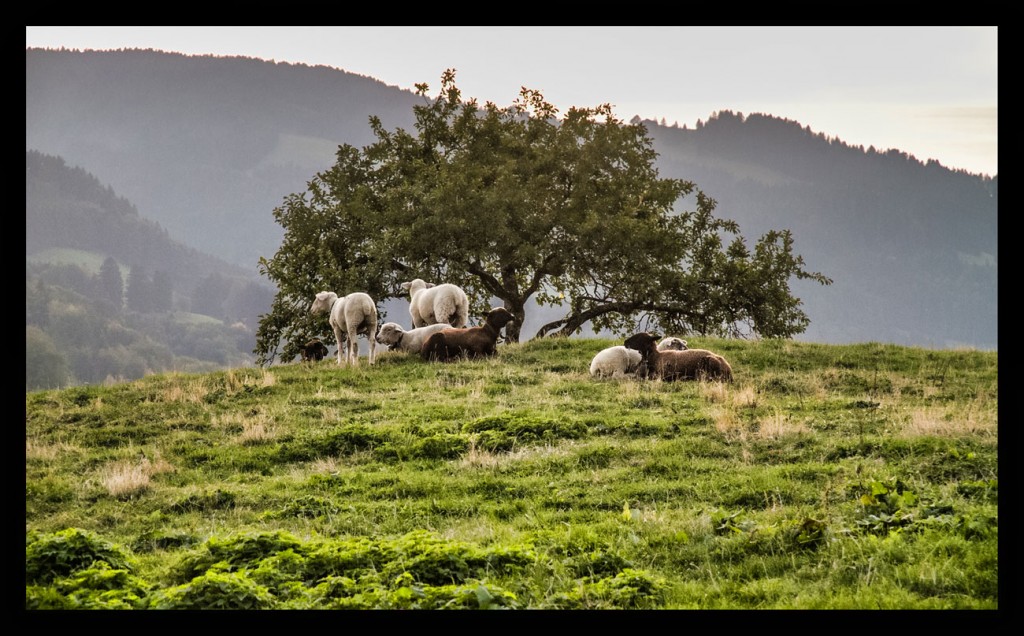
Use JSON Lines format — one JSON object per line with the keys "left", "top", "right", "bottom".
{"left": 26, "top": 49, "right": 998, "bottom": 348}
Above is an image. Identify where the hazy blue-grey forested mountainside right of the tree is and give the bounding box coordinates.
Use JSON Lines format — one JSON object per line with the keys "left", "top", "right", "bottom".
{"left": 647, "top": 112, "right": 998, "bottom": 348}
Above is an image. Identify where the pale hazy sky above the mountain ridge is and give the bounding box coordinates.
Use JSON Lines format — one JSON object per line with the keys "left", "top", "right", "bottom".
{"left": 26, "top": 27, "right": 998, "bottom": 175}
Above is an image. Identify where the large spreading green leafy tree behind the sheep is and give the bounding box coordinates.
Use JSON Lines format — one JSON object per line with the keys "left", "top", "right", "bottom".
{"left": 255, "top": 70, "right": 830, "bottom": 363}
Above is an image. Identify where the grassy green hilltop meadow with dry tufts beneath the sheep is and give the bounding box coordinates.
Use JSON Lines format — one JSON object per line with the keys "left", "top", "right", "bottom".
{"left": 26, "top": 337, "right": 998, "bottom": 609}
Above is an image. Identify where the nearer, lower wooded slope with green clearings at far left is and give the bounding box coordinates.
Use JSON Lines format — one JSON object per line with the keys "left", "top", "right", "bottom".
{"left": 26, "top": 152, "right": 273, "bottom": 389}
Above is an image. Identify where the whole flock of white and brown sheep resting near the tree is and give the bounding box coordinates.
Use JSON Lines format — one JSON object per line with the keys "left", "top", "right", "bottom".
{"left": 302, "top": 279, "right": 732, "bottom": 381}
